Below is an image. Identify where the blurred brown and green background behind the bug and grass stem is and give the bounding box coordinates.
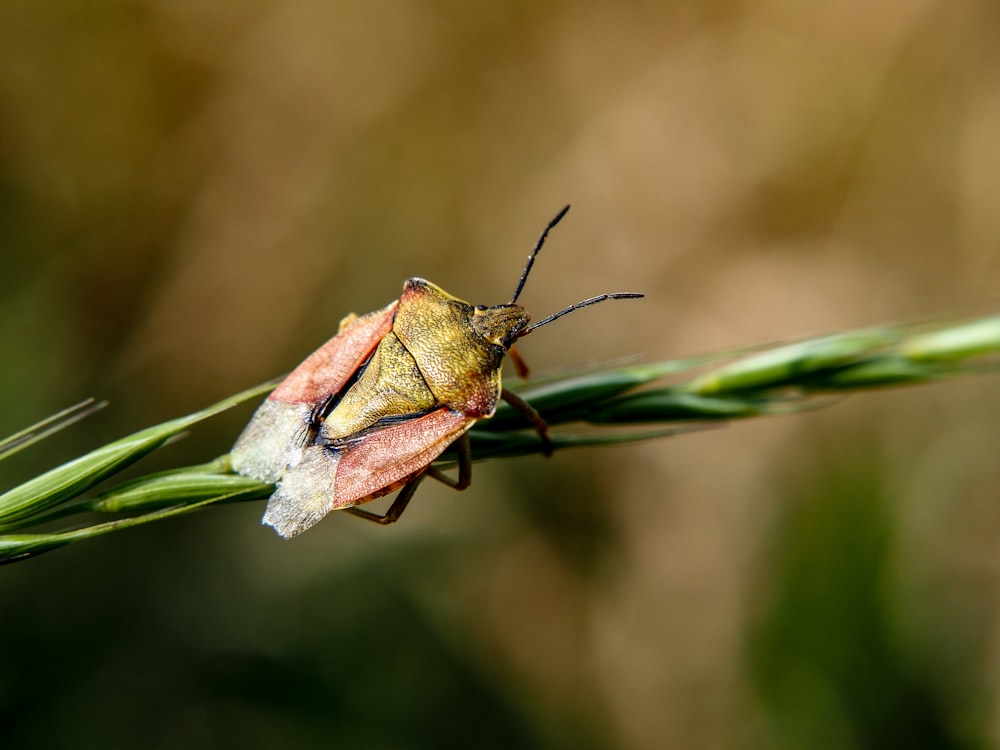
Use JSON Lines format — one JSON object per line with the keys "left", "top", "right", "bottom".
{"left": 0, "top": 0, "right": 1000, "bottom": 750}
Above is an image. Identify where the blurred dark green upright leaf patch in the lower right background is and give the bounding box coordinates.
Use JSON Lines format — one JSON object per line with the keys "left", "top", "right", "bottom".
{"left": 750, "top": 444, "right": 983, "bottom": 748}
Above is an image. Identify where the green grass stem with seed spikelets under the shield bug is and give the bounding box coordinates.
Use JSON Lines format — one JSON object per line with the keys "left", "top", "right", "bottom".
{"left": 0, "top": 316, "right": 1000, "bottom": 563}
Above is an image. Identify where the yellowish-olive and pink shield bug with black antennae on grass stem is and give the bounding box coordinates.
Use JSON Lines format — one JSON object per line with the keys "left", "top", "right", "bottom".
{"left": 230, "top": 206, "right": 643, "bottom": 538}
